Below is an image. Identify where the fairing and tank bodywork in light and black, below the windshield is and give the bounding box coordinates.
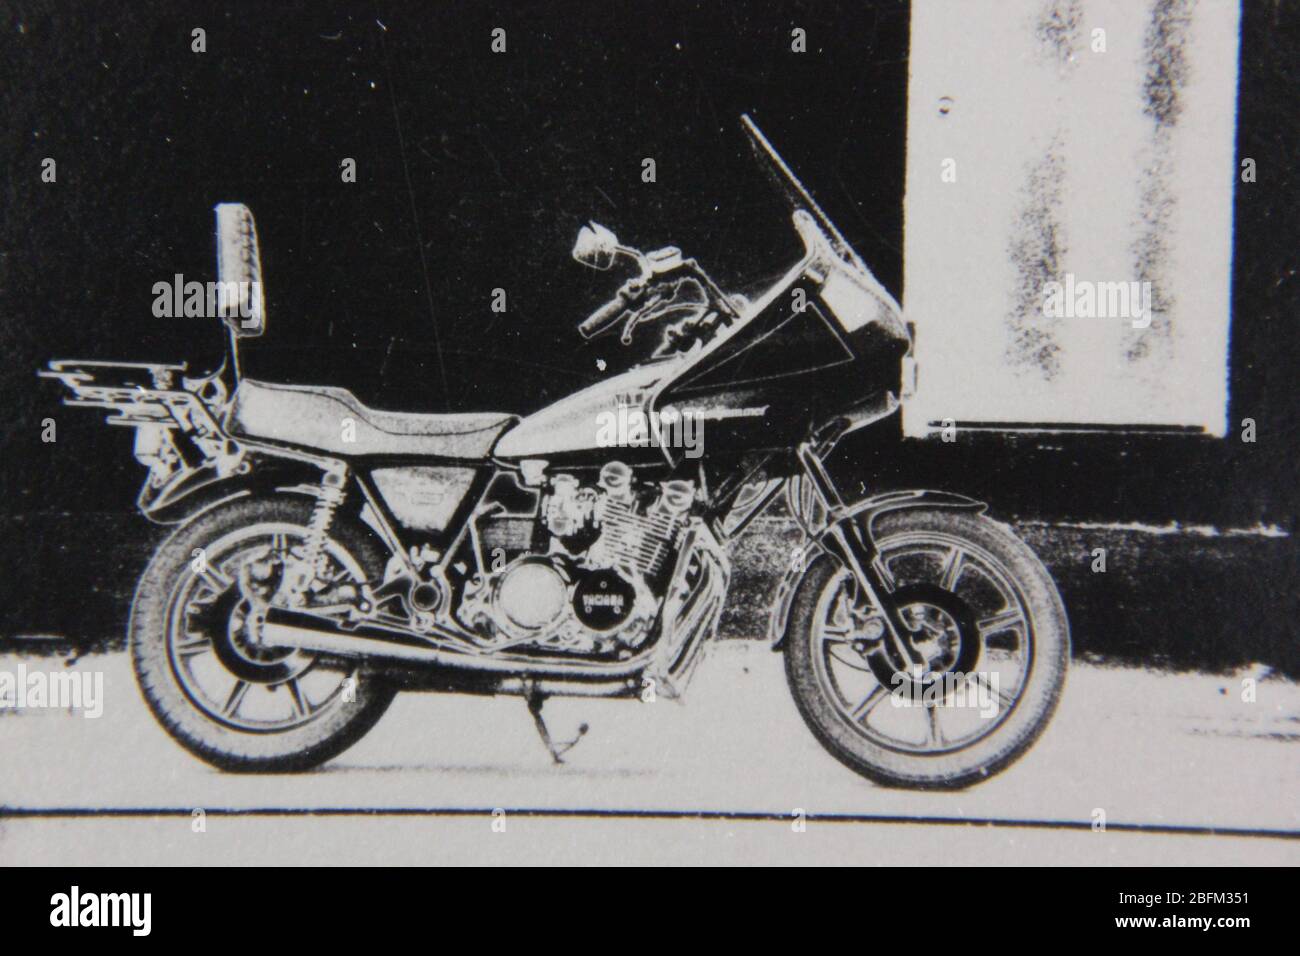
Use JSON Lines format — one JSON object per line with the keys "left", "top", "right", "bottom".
{"left": 494, "top": 211, "right": 911, "bottom": 463}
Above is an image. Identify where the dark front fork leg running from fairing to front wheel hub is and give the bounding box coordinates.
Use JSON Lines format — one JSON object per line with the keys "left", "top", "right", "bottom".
{"left": 796, "top": 438, "right": 924, "bottom": 671}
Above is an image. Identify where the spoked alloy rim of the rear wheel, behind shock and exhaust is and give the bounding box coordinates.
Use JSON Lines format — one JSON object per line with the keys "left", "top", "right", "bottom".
{"left": 166, "top": 523, "right": 365, "bottom": 734}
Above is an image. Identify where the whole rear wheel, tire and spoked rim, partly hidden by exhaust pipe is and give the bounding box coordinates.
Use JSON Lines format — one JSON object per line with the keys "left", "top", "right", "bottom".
{"left": 130, "top": 494, "right": 394, "bottom": 773}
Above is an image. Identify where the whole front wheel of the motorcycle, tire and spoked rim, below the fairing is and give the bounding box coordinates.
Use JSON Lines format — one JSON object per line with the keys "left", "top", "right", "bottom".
{"left": 784, "top": 509, "right": 1070, "bottom": 790}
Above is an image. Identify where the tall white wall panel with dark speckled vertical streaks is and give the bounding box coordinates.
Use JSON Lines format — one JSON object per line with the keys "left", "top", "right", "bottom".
{"left": 904, "top": 0, "right": 1239, "bottom": 434}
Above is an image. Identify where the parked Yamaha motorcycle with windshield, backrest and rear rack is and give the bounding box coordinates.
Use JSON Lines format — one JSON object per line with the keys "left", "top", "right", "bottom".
{"left": 40, "top": 116, "right": 1070, "bottom": 788}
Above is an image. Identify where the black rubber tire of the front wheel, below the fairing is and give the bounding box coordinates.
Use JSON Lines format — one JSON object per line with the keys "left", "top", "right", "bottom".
{"left": 784, "top": 509, "right": 1070, "bottom": 790}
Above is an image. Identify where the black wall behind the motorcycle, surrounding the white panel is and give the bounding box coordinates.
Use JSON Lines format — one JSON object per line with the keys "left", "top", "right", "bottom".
{"left": 0, "top": 0, "right": 1300, "bottom": 671}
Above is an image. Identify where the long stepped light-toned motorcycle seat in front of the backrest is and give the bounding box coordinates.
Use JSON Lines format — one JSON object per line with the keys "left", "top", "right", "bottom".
{"left": 228, "top": 378, "right": 516, "bottom": 459}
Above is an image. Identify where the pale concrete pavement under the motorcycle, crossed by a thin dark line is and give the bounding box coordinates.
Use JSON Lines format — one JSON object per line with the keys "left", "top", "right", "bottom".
{"left": 0, "top": 641, "right": 1300, "bottom": 864}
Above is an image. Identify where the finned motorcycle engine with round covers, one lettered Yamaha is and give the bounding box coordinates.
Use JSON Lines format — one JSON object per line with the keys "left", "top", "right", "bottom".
{"left": 460, "top": 462, "right": 694, "bottom": 653}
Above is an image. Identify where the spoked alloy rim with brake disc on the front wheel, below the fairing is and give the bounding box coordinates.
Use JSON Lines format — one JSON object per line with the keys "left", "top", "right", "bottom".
{"left": 811, "top": 531, "right": 1034, "bottom": 756}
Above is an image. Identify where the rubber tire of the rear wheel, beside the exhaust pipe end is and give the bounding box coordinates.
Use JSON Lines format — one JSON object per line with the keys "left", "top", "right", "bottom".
{"left": 130, "top": 494, "right": 394, "bottom": 773}
